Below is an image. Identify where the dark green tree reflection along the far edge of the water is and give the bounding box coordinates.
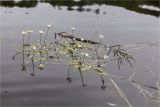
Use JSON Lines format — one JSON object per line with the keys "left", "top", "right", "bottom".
{"left": 0, "top": 0, "right": 160, "bottom": 17}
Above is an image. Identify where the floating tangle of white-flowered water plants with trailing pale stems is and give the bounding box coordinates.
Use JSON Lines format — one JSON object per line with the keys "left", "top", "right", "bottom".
{"left": 12, "top": 25, "right": 160, "bottom": 107}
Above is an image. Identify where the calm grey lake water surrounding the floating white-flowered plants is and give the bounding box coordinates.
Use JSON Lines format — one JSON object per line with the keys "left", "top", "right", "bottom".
{"left": 0, "top": 0, "right": 160, "bottom": 107}
